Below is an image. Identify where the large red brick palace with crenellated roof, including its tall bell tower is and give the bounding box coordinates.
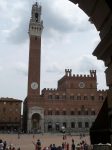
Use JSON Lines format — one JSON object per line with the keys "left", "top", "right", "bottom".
{"left": 23, "top": 3, "right": 106, "bottom": 133}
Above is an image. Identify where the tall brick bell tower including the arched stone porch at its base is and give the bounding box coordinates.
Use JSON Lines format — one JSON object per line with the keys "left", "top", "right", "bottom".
{"left": 23, "top": 2, "right": 44, "bottom": 132}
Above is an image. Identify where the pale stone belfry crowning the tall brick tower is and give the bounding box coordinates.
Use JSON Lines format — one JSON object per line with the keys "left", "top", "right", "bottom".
{"left": 29, "top": 2, "right": 43, "bottom": 37}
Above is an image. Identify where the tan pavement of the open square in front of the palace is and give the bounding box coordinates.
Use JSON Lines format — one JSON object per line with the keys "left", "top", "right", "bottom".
{"left": 0, "top": 134, "right": 90, "bottom": 150}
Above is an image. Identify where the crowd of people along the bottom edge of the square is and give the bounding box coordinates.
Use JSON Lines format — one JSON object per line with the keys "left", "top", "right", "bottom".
{"left": 0, "top": 135, "right": 91, "bottom": 150}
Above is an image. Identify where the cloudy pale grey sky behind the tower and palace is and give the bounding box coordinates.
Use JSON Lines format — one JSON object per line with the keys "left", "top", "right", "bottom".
{"left": 0, "top": 0, "right": 107, "bottom": 100}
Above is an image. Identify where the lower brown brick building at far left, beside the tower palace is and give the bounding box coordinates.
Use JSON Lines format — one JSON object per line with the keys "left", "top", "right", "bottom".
{"left": 0, "top": 98, "right": 22, "bottom": 131}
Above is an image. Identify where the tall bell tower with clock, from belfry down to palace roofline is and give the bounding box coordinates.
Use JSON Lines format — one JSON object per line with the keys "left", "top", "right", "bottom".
{"left": 27, "top": 2, "right": 43, "bottom": 96}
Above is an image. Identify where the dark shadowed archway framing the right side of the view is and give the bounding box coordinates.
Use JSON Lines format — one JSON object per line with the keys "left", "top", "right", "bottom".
{"left": 70, "top": 0, "right": 112, "bottom": 144}
